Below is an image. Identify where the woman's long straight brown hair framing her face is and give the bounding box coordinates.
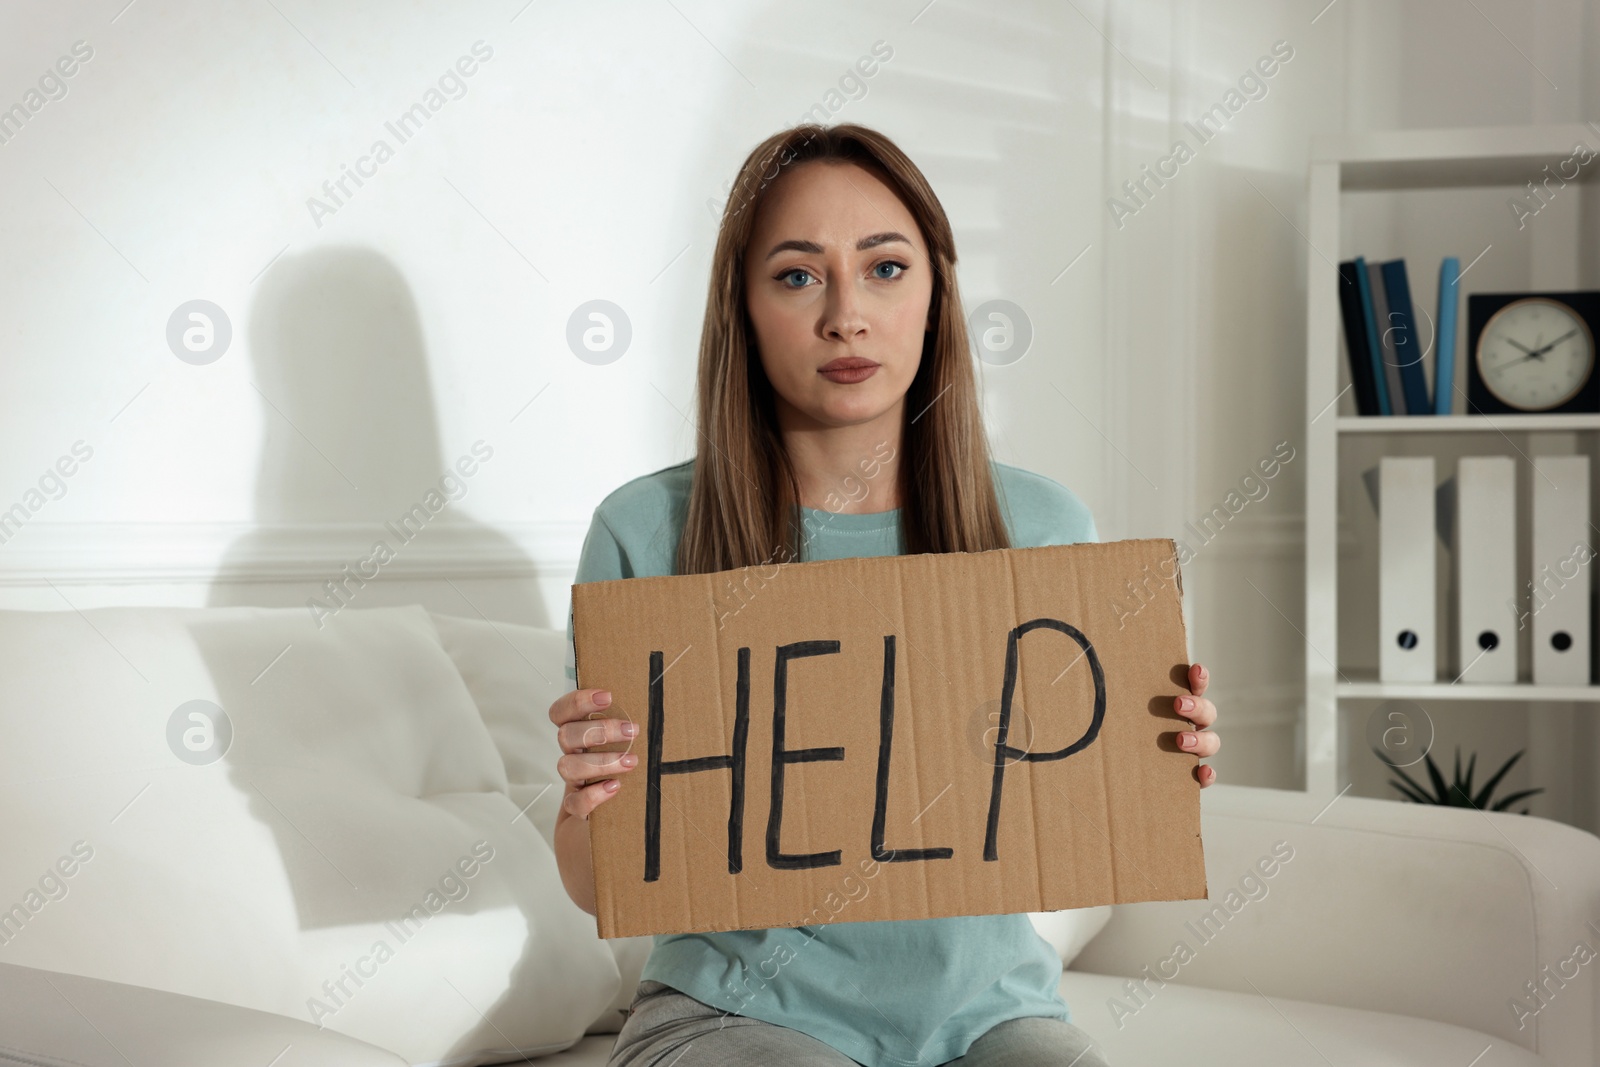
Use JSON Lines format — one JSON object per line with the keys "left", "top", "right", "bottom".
{"left": 677, "top": 123, "right": 1010, "bottom": 574}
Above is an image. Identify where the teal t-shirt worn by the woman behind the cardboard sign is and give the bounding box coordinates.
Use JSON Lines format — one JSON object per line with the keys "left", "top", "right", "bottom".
{"left": 566, "top": 461, "right": 1099, "bottom": 1067}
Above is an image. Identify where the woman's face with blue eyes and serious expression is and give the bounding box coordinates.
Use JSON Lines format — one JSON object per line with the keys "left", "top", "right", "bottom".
{"left": 744, "top": 162, "right": 933, "bottom": 430}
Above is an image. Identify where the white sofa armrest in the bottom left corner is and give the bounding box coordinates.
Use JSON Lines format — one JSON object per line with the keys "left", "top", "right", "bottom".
{"left": 0, "top": 963, "right": 406, "bottom": 1067}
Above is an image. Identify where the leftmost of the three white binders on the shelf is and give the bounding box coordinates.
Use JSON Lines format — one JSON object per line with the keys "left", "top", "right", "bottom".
{"left": 1378, "top": 456, "right": 1438, "bottom": 681}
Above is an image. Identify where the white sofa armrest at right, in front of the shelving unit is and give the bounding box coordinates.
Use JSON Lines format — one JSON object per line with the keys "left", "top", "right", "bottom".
{"left": 1070, "top": 785, "right": 1600, "bottom": 1065}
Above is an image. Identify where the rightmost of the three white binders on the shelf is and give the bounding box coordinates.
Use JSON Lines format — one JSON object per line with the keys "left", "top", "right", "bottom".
{"left": 1523, "top": 456, "right": 1594, "bottom": 685}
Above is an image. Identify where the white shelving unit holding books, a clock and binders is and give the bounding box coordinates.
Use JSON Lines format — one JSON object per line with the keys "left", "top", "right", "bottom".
{"left": 1296, "top": 122, "right": 1600, "bottom": 800}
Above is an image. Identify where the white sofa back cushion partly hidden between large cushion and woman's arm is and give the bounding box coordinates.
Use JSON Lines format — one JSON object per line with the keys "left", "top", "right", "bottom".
{"left": 432, "top": 614, "right": 656, "bottom": 1033}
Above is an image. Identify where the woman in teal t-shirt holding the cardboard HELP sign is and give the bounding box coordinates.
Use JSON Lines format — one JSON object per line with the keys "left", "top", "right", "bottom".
{"left": 550, "top": 125, "right": 1219, "bottom": 1067}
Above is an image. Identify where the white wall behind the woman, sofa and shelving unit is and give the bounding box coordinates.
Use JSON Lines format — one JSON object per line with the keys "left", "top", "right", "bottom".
{"left": 0, "top": 0, "right": 1600, "bottom": 795}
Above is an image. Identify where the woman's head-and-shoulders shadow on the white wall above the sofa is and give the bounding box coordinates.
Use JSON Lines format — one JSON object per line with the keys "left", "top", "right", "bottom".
{"left": 208, "top": 246, "right": 534, "bottom": 625}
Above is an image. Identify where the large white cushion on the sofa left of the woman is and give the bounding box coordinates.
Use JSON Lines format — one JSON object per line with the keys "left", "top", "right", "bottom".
{"left": 0, "top": 605, "right": 618, "bottom": 1064}
